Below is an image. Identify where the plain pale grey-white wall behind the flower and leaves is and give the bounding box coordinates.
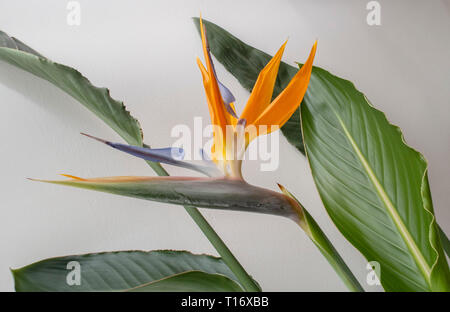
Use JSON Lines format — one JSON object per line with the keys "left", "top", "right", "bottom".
{"left": 0, "top": 0, "right": 450, "bottom": 291}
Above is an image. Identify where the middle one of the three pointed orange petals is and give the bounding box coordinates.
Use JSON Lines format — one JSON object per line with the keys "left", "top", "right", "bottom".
{"left": 241, "top": 41, "right": 287, "bottom": 124}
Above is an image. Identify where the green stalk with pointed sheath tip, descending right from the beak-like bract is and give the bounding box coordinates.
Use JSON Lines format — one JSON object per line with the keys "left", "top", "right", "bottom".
{"left": 278, "top": 184, "right": 364, "bottom": 292}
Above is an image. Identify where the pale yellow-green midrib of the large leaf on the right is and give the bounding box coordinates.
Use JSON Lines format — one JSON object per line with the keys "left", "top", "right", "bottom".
{"left": 333, "top": 110, "right": 431, "bottom": 285}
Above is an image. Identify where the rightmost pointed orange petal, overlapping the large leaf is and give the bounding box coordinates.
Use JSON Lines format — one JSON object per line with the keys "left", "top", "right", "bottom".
{"left": 254, "top": 41, "right": 317, "bottom": 134}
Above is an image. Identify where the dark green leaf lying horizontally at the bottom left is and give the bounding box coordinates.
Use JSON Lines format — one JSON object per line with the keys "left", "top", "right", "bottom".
{"left": 12, "top": 250, "right": 241, "bottom": 291}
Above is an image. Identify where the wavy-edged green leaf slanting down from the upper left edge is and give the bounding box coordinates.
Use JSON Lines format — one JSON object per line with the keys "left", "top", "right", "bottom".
{"left": 0, "top": 31, "right": 142, "bottom": 146}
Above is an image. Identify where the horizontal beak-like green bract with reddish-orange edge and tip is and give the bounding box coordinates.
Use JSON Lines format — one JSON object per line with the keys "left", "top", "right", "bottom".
{"left": 37, "top": 177, "right": 298, "bottom": 220}
